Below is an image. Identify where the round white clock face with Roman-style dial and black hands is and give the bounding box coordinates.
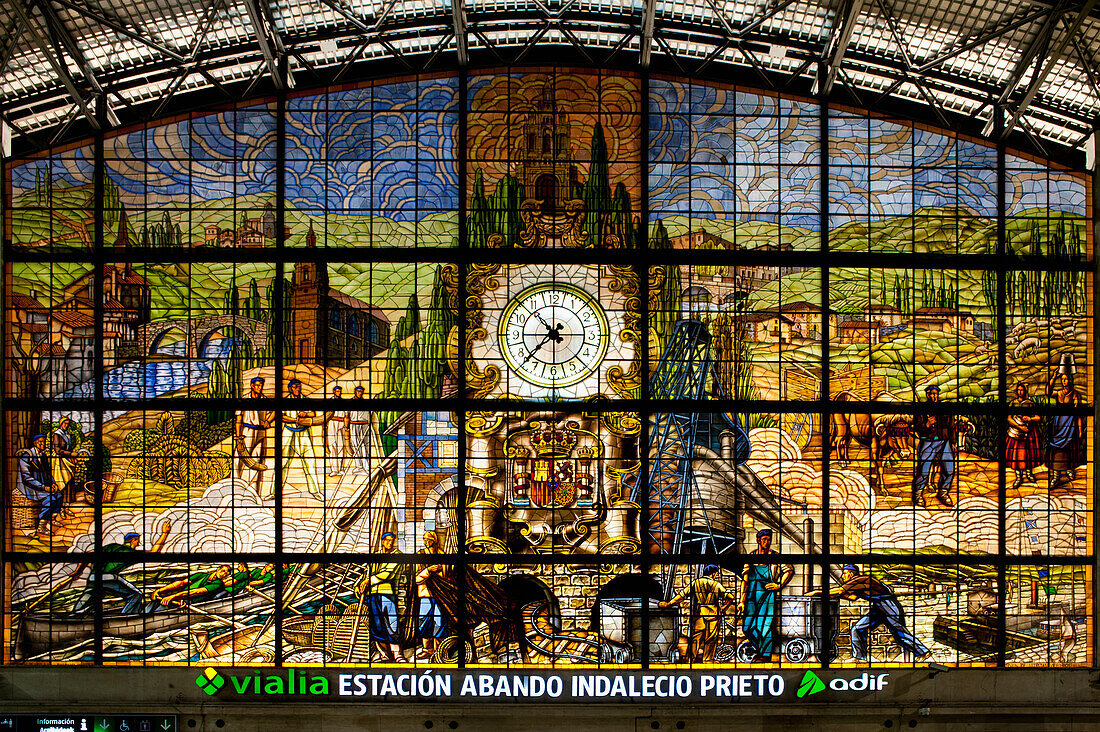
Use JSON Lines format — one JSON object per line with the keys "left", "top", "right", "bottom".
{"left": 498, "top": 282, "right": 609, "bottom": 387}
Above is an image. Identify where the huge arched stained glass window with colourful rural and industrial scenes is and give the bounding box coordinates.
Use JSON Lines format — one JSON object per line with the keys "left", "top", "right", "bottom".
{"left": 2, "top": 67, "right": 1096, "bottom": 670}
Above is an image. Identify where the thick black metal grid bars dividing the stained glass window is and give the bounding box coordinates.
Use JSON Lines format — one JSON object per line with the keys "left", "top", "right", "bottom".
{"left": 0, "top": 66, "right": 1100, "bottom": 667}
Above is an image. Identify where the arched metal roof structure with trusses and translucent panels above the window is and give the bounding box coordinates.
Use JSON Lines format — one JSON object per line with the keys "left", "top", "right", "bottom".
{"left": 0, "top": 0, "right": 1100, "bottom": 154}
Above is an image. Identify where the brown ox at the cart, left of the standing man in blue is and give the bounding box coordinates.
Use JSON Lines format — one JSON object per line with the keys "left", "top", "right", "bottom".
{"left": 829, "top": 392, "right": 913, "bottom": 491}
